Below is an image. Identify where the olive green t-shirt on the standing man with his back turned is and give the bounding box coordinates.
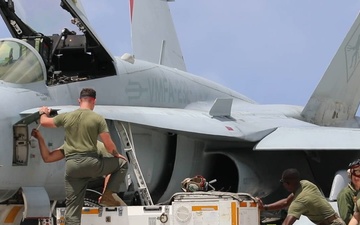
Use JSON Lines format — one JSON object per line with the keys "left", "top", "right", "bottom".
{"left": 54, "top": 109, "right": 109, "bottom": 156}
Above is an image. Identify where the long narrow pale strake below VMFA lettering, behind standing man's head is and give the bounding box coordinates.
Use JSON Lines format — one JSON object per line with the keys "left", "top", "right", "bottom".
{"left": 21, "top": 105, "right": 262, "bottom": 139}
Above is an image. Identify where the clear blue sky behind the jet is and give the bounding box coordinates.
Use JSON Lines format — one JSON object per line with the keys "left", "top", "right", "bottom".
{"left": 0, "top": 0, "right": 360, "bottom": 106}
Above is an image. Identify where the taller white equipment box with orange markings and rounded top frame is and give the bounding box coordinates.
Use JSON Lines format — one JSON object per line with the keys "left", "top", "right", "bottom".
{"left": 172, "top": 192, "right": 260, "bottom": 225}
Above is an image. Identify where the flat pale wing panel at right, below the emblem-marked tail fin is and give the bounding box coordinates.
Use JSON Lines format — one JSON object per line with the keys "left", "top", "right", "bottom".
{"left": 254, "top": 127, "right": 360, "bottom": 150}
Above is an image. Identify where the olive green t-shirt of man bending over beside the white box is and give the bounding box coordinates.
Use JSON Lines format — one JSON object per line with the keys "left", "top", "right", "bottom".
{"left": 288, "top": 180, "right": 335, "bottom": 224}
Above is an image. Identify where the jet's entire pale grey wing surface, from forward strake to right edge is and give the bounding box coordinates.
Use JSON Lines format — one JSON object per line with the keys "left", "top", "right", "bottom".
{"left": 21, "top": 105, "right": 360, "bottom": 150}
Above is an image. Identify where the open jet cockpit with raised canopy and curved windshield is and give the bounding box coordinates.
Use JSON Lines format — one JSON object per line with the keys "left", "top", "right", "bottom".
{"left": 0, "top": 0, "right": 116, "bottom": 86}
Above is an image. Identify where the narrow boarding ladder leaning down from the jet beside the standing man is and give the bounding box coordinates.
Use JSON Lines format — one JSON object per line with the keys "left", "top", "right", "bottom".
{"left": 115, "top": 121, "right": 153, "bottom": 205}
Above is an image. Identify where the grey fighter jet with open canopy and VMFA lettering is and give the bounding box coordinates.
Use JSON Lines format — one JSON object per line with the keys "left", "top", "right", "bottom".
{"left": 0, "top": 0, "right": 360, "bottom": 223}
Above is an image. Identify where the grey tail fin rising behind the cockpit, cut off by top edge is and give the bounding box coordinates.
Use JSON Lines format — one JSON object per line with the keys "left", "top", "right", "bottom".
{"left": 130, "top": 0, "right": 186, "bottom": 71}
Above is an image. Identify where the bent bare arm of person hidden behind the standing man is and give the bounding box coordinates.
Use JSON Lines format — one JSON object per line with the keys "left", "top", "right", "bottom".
{"left": 31, "top": 129, "right": 65, "bottom": 163}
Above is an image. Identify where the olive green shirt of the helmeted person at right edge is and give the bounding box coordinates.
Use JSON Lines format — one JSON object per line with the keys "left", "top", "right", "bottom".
{"left": 337, "top": 184, "right": 359, "bottom": 224}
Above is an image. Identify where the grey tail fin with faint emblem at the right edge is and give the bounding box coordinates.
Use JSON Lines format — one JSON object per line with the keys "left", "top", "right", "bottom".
{"left": 302, "top": 12, "right": 360, "bottom": 126}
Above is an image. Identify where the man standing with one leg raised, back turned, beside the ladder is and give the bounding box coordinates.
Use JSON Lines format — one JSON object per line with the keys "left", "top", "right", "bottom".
{"left": 39, "top": 88, "right": 128, "bottom": 225}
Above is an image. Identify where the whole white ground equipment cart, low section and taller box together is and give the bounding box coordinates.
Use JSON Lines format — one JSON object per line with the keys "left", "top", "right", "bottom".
{"left": 56, "top": 192, "right": 260, "bottom": 225}
